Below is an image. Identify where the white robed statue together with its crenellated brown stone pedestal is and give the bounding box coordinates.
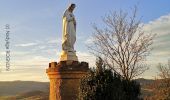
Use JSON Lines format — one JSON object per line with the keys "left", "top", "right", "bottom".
{"left": 46, "top": 4, "right": 89, "bottom": 100}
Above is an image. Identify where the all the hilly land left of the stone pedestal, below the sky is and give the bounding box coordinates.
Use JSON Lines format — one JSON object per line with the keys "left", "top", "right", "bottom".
{"left": 0, "top": 81, "right": 49, "bottom": 100}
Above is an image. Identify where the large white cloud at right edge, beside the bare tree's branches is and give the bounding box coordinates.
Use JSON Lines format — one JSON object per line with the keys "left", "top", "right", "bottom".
{"left": 144, "top": 14, "right": 170, "bottom": 59}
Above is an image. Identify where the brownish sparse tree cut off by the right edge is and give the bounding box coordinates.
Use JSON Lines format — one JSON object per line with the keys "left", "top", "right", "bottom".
{"left": 147, "top": 60, "right": 170, "bottom": 100}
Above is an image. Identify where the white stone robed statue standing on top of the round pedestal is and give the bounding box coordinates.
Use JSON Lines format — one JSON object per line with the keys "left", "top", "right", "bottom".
{"left": 60, "top": 4, "right": 78, "bottom": 61}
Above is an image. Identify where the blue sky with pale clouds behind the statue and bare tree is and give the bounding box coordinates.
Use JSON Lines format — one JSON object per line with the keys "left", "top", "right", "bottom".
{"left": 0, "top": 0, "right": 170, "bottom": 81}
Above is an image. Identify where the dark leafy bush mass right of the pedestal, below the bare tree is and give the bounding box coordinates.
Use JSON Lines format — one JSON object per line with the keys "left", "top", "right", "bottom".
{"left": 79, "top": 58, "right": 140, "bottom": 100}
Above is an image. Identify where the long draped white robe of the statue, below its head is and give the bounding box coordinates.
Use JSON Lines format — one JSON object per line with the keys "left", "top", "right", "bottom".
{"left": 62, "top": 10, "right": 76, "bottom": 52}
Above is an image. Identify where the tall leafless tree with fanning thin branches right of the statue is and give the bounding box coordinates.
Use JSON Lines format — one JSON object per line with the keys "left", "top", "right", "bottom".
{"left": 89, "top": 8, "right": 154, "bottom": 80}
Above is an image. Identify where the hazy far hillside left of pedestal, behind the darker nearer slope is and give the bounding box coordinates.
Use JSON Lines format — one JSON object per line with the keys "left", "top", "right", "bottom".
{"left": 0, "top": 81, "right": 49, "bottom": 96}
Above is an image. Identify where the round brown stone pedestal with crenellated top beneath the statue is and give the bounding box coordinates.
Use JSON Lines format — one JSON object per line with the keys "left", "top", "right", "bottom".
{"left": 46, "top": 61, "right": 88, "bottom": 100}
